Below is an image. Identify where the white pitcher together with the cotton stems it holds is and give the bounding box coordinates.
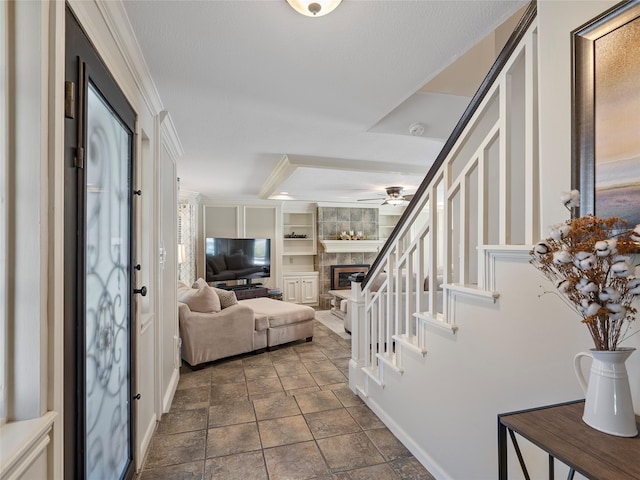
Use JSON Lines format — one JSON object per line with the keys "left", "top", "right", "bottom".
{"left": 530, "top": 190, "right": 640, "bottom": 437}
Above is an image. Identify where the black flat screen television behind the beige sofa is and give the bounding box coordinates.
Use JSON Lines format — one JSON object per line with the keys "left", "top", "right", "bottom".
{"left": 205, "top": 237, "right": 271, "bottom": 284}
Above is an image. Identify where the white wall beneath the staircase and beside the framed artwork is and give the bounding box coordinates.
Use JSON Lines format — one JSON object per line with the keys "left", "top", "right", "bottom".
{"left": 356, "top": 1, "right": 640, "bottom": 480}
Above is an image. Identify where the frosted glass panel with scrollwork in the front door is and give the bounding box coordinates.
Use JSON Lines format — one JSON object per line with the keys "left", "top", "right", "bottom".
{"left": 84, "top": 82, "right": 133, "bottom": 480}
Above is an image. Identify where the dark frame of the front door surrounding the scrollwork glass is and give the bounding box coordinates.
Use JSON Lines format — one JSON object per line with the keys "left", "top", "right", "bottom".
{"left": 61, "top": 6, "right": 136, "bottom": 480}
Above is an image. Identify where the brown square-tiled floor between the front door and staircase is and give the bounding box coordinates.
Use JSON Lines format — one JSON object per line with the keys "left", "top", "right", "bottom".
{"left": 138, "top": 321, "right": 433, "bottom": 480}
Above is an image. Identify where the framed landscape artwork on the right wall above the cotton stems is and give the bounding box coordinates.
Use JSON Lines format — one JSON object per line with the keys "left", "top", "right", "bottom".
{"left": 572, "top": 0, "right": 640, "bottom": 227}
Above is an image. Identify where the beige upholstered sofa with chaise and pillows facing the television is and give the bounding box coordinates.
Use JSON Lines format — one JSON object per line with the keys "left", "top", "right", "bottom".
{"left": 178, "top": 279, "right": 315, "bottom": 366}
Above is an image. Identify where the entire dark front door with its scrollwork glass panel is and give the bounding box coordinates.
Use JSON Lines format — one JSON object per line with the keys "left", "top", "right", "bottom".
{"left": 65, "top": 10, "right": 136, "bottom": 480}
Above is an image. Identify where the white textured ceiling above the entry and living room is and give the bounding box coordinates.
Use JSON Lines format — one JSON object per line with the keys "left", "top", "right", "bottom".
{"left": 124, "top": 0, "right": 526, "bottom": 201}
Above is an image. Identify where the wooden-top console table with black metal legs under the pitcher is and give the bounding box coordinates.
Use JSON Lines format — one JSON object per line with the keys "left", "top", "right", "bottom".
{"left": 498, "top": 400, "right": 640, "bottom": 480}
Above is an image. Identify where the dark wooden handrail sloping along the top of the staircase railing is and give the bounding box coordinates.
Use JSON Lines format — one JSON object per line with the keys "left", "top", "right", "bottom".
{"left": 362, "top": 0, "right": 538, "bottom": 289}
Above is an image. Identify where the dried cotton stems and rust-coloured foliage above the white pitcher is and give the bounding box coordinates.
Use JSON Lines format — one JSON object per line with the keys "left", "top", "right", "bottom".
{"left": 530, "top": 190, "right": 640, "bottom": 350}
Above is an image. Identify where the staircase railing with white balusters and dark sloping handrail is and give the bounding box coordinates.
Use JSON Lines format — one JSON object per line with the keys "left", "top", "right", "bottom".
{"left": 349, "top": 4, "right": 539, "bottom": 395}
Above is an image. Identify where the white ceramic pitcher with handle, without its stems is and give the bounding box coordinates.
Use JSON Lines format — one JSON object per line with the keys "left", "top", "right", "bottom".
{"left": 573, "top": 348, "right": 638, "bottom": 437}
